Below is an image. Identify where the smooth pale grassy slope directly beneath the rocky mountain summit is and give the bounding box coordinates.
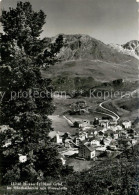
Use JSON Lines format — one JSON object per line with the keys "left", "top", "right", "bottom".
{"left": 42, "top": 59, "right": 138, "bottom": 82}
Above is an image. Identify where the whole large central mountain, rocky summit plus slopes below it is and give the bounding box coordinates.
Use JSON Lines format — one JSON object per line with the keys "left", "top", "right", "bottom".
{"left": 42, "top": 34, "right": 139, "bottom": 91}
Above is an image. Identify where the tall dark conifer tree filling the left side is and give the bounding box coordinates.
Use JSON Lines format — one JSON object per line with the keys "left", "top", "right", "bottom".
{"left": 0, "top": 2, "right": 62, "bottom": 183}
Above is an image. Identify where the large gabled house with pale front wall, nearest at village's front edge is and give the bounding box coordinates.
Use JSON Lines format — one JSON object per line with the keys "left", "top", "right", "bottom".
{"left": 79, "top": 142, "right": 96, "bottom": 159}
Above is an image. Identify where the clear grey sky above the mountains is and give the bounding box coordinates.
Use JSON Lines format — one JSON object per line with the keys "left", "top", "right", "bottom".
{"left": 1, "top": 0, "right": 138, "bottom": 44}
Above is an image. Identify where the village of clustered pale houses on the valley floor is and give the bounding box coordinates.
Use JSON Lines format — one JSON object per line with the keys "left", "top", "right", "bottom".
{"left": 51, "top": 102, "right": 139, "bottom": 164}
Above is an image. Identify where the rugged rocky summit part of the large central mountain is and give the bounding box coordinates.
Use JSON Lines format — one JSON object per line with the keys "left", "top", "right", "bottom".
{"left": 54, "top": 34, "right": 135, "bottom": 62}
